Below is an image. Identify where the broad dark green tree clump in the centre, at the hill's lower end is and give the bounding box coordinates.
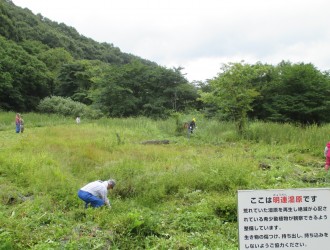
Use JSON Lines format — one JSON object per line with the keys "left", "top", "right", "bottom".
{"left": 91, "top": 61, "right": 197, "bottom": 118}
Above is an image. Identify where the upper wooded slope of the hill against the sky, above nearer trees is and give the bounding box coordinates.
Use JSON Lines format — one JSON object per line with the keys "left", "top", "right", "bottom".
{"left": 0, "top": 0, "right": 139, "bottom": 64}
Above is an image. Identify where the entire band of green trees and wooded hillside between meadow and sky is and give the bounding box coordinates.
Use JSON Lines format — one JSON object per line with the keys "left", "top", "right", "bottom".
{"left": 0, "top": 0, "right": 330, "bottom": 123}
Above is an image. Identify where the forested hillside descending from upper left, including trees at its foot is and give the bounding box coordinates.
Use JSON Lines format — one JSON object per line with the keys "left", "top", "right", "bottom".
{"left": 0, "top": 0, "right": 197, "bottom": 117}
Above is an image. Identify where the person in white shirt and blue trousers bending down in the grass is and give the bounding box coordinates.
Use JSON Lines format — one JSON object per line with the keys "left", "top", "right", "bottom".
{"left": 78, "top": 179, "right": 116, "bottom": 208}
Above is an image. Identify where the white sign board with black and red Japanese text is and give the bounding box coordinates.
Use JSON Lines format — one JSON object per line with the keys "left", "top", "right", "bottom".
{"left": 238, "top": 188, "right": 330, "bottom": 250}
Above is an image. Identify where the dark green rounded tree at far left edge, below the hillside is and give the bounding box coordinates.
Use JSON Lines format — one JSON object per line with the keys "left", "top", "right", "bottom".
{"left": 0, "top": 36, "right": 51, "bottom": 111}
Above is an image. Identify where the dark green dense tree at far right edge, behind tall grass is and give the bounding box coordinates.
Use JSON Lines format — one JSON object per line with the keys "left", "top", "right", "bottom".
{"left": 256, "top": 62, "right": 330, "bottom": 124}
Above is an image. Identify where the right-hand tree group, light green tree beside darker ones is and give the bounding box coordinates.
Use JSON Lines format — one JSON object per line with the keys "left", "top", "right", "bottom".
{"left": 200, "top": 62, "right": 330, "bottom": 127}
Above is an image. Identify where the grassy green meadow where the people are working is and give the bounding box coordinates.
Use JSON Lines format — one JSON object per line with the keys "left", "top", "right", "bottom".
{"left": 0, "top": 112, "right": 330, "bottom": 250}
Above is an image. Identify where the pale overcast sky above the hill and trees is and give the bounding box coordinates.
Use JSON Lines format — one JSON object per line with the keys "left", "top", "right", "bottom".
{"left": 13, "top": 0, "right": 330, "bottom": 81}
